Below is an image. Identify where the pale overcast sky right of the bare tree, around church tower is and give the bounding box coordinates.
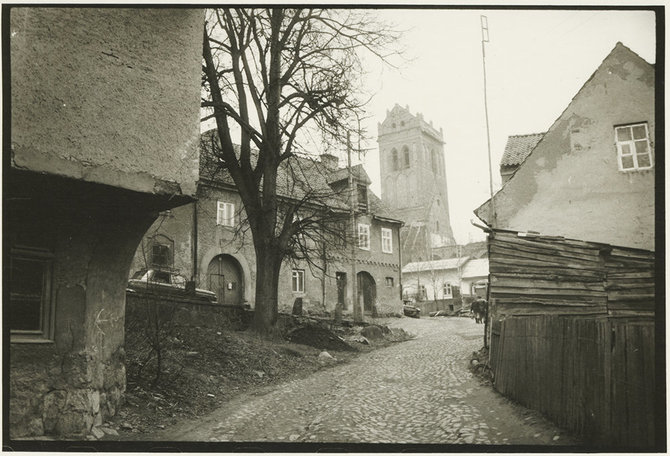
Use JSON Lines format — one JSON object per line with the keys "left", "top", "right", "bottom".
{"left": 354, "top": 9, "right": 656, "bottom": 243}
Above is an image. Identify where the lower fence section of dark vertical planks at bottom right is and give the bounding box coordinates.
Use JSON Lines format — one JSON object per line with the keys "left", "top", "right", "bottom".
{"left": 491, "top": 316, "right": 656, "bottom": 448}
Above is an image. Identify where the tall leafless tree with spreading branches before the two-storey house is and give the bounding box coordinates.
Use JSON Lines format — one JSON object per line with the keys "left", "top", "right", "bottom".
{"left": 203, "top": 8, "right": 397, "bottom": 333}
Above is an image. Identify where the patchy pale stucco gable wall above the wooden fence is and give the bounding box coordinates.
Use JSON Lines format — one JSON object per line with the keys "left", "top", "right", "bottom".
{"left": 477, "top": 45, "right": 655, "bottom": 250}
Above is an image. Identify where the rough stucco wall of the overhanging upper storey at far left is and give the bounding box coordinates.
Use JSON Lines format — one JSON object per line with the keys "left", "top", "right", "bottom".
{"left": 10, "top": 8, "right": 204, "bottom": 195}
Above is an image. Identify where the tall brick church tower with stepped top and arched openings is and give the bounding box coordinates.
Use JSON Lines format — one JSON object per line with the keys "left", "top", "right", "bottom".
{"left": 377, "top": 104, "right": 456, "bottom": 265}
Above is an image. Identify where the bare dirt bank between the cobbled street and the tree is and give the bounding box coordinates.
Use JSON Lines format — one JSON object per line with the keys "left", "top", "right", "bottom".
{"left": 103, "top": 315, "right": 411, "bottom": 440}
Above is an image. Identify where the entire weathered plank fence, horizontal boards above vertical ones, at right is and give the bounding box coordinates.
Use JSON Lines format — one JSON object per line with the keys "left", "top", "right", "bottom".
{"left": 489, "top": 230, "right": 655, "bottom": 448}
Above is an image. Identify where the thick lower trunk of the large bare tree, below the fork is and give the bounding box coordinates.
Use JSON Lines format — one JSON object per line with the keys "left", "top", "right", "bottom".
{"left": 253, "top": 250, "right": 282, "bottom": 335}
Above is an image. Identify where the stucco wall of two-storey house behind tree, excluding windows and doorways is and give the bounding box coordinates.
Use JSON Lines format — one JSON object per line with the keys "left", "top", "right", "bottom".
{"left": 131, "top": 185, "right": 402, "bottom": 314}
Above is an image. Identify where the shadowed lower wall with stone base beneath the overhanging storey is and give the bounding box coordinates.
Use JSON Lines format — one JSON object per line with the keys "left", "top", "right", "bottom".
{"left": 7, "top": 179, "right": 158, "bottom": 437}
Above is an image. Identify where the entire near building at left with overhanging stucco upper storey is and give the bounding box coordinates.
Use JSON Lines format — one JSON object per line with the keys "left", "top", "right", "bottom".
{"left": 3, "top": 7, "right": 204, "bottom": 438}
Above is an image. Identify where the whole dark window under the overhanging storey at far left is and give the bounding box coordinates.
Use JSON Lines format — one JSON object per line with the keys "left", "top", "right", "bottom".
{"left": 8, "top": 249, "right": 53, "bottom": 341}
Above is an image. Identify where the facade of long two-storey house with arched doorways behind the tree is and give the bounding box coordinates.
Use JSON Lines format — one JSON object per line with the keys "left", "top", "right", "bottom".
{"left": 131, "top": 133, "right": 402, "bottom": 316}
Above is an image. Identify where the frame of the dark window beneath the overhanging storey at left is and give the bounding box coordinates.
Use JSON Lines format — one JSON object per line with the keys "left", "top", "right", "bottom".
{"left": 7, "top": 247, "right": 55, "bottom": 343}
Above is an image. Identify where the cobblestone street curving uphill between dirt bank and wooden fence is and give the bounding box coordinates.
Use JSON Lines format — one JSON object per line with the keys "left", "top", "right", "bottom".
{"left": 148, "top": 317, "right": 575, "bottom": 445}
